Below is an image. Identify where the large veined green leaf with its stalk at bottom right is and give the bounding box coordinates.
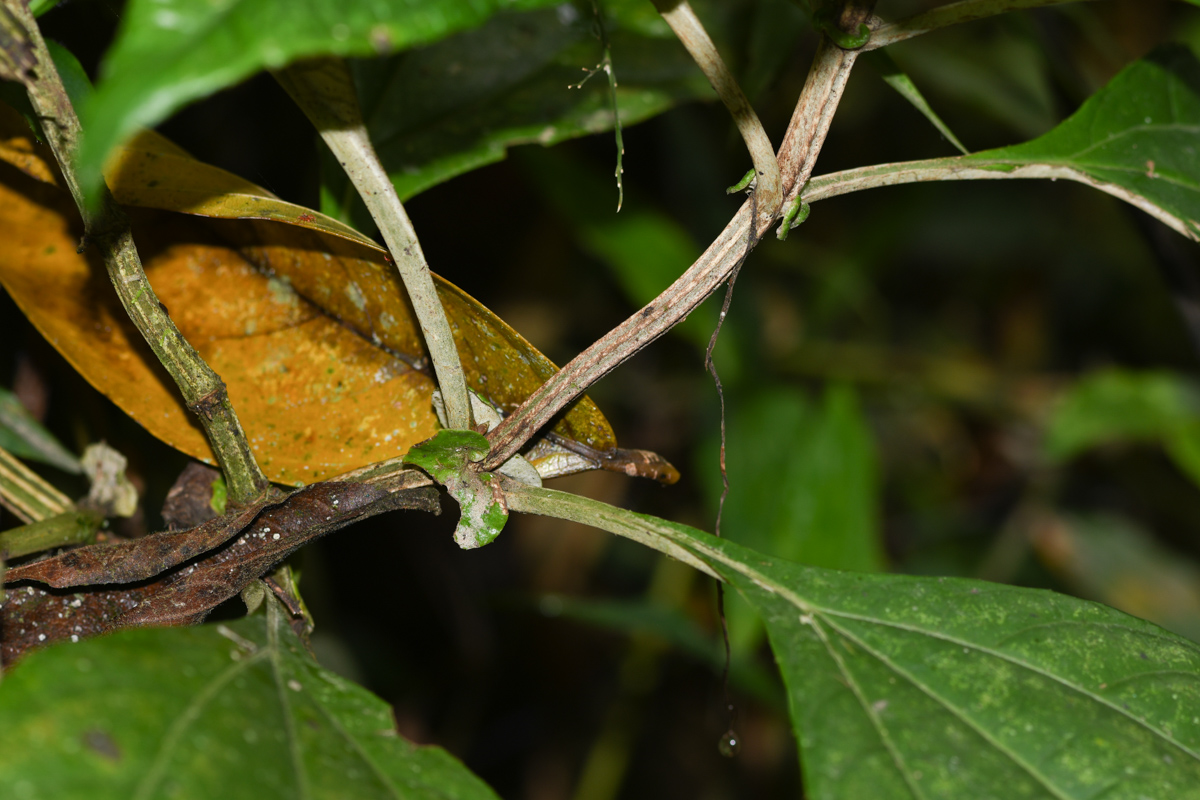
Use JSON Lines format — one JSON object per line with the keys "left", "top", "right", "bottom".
{"left": 509, "top": 487, "right": 1200, "bottom": 800}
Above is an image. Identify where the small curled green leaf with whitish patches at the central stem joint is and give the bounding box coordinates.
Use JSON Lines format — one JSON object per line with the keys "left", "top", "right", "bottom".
{"left": 404, "top": 431, "right": 509, "bottom": 549}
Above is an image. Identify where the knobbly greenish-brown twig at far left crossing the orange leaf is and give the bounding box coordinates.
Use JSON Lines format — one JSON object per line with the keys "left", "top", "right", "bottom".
{"left": 2, "top": 0, "right": 270, "bottom": 504}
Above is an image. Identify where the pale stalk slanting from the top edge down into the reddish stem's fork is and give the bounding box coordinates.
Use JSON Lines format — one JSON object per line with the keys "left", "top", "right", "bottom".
{"left": 654, "top": 0, "right": 782, "bottom": 227}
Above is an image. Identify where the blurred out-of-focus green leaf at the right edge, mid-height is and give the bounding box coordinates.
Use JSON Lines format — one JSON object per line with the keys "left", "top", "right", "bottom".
{"left": 1045, "top": 369, "right": 1200, "bottom": 483}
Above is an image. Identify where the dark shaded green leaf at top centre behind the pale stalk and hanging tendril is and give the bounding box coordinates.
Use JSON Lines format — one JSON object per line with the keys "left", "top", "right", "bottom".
{"left": 322, "top": 0, "right": 713, "bottom": 227}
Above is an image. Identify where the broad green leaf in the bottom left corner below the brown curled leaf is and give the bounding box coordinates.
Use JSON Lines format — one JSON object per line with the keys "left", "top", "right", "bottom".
{"left": 0, "top": 601, "right": 496, "bottom": 800}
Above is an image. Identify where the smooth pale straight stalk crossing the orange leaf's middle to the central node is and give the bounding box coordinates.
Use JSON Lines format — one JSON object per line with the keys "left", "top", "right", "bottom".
{"left": 275, "top": 58, "right": 472, "bottom": 431}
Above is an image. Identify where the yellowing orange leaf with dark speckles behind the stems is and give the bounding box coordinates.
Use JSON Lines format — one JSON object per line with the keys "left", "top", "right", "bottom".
{"left": 0, "top": 108, "right": 677, "bottom": 485}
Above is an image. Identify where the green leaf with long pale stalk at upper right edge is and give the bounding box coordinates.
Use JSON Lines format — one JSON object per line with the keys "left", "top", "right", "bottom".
{"left": 804, "top": 44, "right": 1200, "bottom": 239}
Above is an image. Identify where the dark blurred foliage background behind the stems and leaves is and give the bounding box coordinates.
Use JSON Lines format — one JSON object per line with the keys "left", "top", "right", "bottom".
{"left": 0, "top": 0, "right": 1200, "bottom": 800}
